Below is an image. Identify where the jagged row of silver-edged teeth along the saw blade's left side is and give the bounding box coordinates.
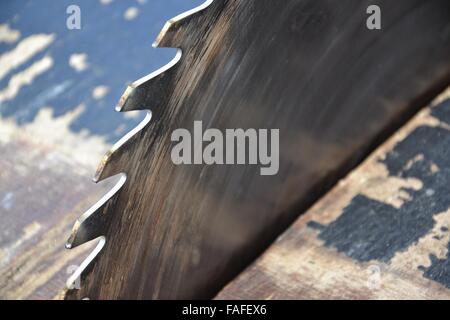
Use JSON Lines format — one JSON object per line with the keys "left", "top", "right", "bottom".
{"left": 66, "top": 0, "right": 223, "bottom": 297}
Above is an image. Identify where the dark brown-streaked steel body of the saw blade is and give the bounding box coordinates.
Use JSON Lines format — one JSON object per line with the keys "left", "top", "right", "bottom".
{"left": 68, "top": 0, "right": 450, "bottom": 299}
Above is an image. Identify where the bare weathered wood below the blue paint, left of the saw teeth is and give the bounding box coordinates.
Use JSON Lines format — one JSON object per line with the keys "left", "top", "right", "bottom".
{"left": 0, "top": 134, "right": 111, "bottom": 299}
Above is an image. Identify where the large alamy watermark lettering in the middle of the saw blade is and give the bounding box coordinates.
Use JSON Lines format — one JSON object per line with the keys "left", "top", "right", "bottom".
{"left": 171, "top": 121, "right": 280, "bottom": 176}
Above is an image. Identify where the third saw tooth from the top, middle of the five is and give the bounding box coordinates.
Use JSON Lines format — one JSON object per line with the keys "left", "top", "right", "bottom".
{"left": 94, "top": 111, "right": 152, "bottom": 182}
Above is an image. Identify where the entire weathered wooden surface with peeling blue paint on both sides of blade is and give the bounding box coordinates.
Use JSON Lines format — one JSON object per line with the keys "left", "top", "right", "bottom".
{"left": 0, "top": 0, "right": 450, "bottom": 299}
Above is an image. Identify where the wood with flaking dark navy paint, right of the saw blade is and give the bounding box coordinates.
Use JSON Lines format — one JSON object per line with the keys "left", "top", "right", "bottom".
{"left": 216, "top": 90, "right": 450, "bottom": 299}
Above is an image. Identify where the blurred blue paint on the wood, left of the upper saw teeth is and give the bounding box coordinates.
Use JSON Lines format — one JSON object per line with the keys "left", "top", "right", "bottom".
{"left": 0, "top": 0, "right": 203, "bottom": 142}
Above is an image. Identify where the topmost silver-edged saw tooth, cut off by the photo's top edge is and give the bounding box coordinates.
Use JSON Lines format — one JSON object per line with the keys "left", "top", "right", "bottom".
{"left": 153, "top": 0, "right": 217, "bottom": 48}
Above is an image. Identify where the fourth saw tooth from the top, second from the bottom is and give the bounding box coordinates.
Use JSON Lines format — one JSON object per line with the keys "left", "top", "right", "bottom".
{"left": 66, "top": 174, "right": 126, "bottom": 249}
